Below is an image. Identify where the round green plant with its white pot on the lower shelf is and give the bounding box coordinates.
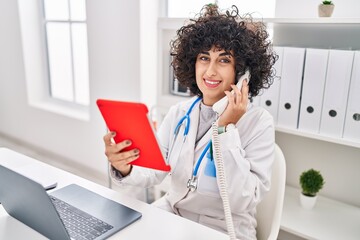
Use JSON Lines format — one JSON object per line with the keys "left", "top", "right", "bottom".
{"left": 299, "top": 169, "right": 325, "bottom": 209}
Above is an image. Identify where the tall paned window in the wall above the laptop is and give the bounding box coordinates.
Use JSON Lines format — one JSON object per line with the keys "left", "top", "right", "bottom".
{"left": 43, "top": 0, "right": 89, "bottom": 106}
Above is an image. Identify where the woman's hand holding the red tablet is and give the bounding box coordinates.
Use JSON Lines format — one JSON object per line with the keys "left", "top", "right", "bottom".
{"left": 103, "top": 132, "right": 140, "bottom": 177}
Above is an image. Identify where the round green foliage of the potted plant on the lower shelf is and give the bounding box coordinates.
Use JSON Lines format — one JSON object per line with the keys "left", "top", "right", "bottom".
{"left": 300, "top": 169, "right": 325, "bottom": 197}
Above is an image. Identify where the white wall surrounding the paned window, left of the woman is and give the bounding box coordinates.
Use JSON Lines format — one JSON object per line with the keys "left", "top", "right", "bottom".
{"left": 0, "top": 0, "right": 140, "bottom": 184}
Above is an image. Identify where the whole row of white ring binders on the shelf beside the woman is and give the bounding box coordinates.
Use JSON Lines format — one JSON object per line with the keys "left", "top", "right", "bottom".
{"left": 254, "top": 47, "right": 360, "bottom": 142}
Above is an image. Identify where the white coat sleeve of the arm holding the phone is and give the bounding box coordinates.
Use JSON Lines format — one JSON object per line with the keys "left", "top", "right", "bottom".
{"left": 217, "top": 111, "right": 275, "bottom": 214}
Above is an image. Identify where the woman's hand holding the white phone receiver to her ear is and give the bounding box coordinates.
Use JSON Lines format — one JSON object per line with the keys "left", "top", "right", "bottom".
{"left": 218, "top": 81, "right": 249, "bottom": 126}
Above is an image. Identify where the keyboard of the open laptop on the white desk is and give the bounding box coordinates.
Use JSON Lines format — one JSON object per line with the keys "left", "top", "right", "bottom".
{"left": 50, "top": 196, "right": 113, "bottom": 240}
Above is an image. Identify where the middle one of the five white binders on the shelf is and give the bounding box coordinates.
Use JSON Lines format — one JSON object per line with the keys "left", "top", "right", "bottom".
{"left": 299, "top": 48, "right": 329, "bottom": 133}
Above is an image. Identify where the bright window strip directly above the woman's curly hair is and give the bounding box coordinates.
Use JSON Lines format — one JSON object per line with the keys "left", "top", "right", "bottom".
{"left": 167, "top": 0, "right": 275, "bottom": 18}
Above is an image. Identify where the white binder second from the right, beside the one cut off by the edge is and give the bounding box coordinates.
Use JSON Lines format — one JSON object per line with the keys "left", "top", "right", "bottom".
{"left": 320, "top": 50, "right": 354, "bottom": 138}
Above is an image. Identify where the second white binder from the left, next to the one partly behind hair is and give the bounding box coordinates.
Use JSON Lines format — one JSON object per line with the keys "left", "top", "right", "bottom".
{"left": 277, "top": 47, "right": 305, "bottom": 129}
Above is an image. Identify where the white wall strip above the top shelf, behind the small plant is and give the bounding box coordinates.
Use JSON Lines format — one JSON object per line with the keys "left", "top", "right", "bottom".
{"left": 275, "top": 0, "right": 360, "bottom": 18}
